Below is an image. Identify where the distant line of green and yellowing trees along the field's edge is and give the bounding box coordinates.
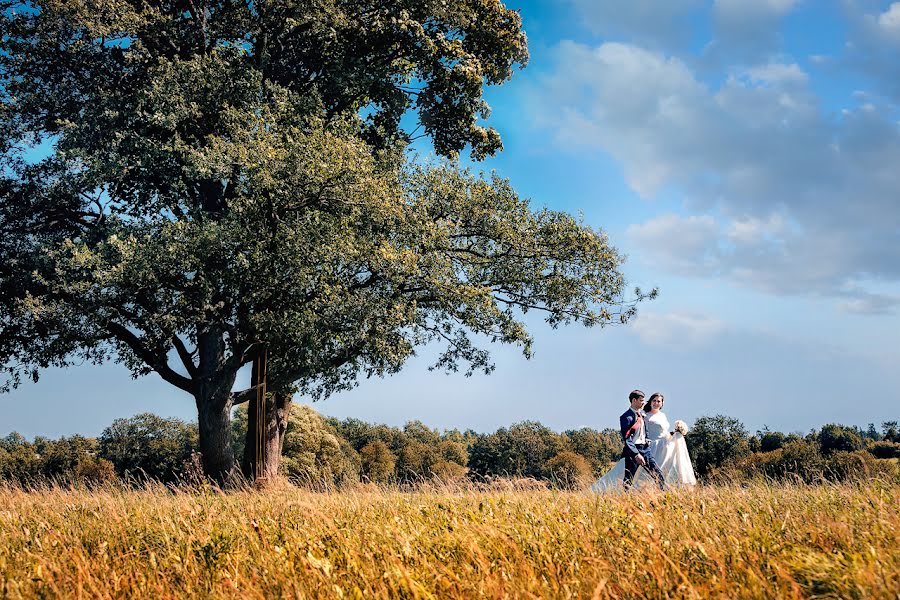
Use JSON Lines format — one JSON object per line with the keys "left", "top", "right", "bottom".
{"left": 0, "top": 405, "right": 900, "bottom": 487}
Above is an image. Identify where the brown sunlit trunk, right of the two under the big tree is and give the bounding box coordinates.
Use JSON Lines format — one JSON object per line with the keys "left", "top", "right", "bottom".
{"left": 241, "top": 386, "right": 293, "bottom": 483}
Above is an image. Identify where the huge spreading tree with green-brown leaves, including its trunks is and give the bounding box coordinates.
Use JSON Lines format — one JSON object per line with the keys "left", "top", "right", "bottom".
{"left": 0, "top": 0, "right": 640, "bottom": 480}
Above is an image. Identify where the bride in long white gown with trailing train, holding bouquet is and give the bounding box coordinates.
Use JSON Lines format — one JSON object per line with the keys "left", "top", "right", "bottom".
{"left": 591, "top": 392, "right": 697, "bottom": 492}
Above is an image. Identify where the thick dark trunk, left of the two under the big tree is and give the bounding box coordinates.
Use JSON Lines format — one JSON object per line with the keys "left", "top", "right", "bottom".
{"left": 194, "top": 325, "right": 237, "bottom": 485}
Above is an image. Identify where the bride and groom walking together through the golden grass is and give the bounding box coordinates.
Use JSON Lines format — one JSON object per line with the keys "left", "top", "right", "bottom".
{"left": 591, "top": 390, "right": 697, "bottom": 492}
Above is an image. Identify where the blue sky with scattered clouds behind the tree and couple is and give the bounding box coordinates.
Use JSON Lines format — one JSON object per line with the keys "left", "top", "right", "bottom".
{"left": 0, "top": 0, "right": 900, "bottom": 437}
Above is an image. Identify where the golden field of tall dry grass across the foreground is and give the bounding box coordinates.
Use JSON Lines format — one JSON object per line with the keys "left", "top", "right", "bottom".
{"left": 0, "top": 481, "right": 900, "bottom": 598}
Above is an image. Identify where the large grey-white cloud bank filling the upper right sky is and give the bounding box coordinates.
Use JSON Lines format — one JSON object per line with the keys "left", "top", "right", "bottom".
{"left": 538, "top": 42, "right": 900, "bottom": 306}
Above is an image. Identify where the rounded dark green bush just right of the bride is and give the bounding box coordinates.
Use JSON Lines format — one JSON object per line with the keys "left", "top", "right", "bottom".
{"left": 685, "top": 415, "right": 750, "bottom": 477}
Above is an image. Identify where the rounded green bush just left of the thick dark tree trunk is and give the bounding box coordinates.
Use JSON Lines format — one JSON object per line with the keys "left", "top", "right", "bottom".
{"left": 99, "top": 413, "right": 197, "bottom": 482}
